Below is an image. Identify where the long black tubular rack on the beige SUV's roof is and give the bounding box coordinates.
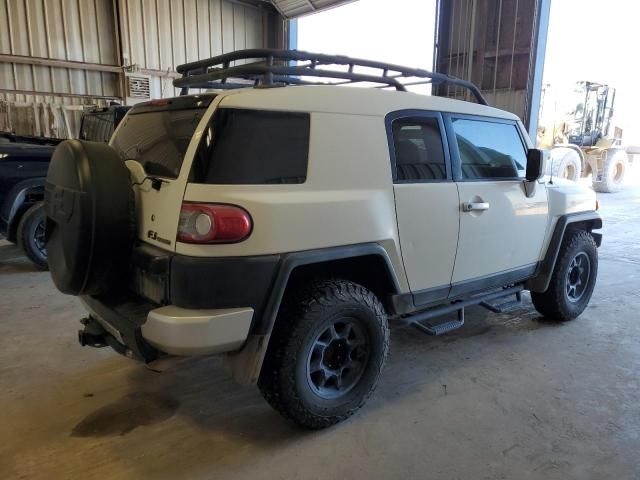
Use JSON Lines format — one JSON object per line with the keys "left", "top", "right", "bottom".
{"left": 173, "top": 48, "right": 487, "bottom": 105}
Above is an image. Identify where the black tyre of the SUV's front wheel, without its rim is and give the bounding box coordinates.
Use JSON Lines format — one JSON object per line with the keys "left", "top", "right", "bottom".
{"left": 531, "top": 230, "right": 598, "bottom": 322}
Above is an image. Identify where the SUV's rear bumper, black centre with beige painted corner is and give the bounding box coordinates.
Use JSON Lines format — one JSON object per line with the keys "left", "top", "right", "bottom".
{"left": 81, "top": 296, "right": 254, "bottom": 362}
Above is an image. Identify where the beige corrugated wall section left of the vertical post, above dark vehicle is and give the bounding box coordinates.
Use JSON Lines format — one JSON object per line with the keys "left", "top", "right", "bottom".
{"left": 0, "top": 0, "right": 118, "bottom": 136}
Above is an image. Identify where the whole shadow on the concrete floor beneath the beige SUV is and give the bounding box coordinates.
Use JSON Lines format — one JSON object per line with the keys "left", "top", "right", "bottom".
{"left": 55, "top": 296, "right": 558, "bottom": 477}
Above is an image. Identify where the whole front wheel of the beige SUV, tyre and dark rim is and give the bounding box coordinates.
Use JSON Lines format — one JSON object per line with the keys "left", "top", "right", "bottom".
{"left": 531, "top": 231, "right": 598, "bottom": 321}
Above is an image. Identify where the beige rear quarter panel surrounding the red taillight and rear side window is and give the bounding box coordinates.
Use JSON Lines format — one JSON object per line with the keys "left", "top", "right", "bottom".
{"left": 176, "top": 110, "right": 407, "bottom": 290}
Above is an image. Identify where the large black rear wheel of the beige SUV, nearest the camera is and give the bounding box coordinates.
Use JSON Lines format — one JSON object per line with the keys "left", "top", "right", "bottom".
{"left": 258, "top": 280, "right": 389, "bottom": 429}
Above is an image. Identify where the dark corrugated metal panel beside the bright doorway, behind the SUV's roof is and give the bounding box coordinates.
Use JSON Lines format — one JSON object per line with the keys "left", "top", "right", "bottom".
{"left": 435, "top": 0, "right": 540, "bottom": 123}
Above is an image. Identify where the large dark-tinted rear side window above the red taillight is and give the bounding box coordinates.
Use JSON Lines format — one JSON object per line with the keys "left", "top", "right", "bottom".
{"left": 190, "top": 108, "right": 310, "bottom": 185}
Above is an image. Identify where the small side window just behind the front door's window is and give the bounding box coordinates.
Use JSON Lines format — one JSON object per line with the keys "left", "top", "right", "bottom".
{"left": 391, "top": 117, "right": 447, "bottom": 181}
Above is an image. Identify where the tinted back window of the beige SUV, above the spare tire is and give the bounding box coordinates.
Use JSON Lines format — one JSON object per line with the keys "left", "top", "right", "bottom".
{"left": 112, "top": 97, "right": 211, "bottom": 178}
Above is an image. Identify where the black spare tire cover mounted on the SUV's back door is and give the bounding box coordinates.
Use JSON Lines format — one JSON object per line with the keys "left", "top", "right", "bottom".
{"left": 45, "top": 140, "right": 135, "bottom": 295}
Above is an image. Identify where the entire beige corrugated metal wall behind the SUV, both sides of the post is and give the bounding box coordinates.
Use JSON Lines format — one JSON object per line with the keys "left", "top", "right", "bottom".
{"left": 0, "top": 0, "right": 284, "bottom": 137}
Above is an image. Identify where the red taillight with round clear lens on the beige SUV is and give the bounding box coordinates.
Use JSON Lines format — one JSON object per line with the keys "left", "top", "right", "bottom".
{"left": 178, "top": 203, "right": 253, "bottom": 243}
